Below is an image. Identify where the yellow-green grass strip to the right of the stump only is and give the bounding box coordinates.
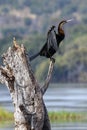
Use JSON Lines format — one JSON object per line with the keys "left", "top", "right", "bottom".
{"left": 49, "top": 111, "right": 87, "bottom": 123}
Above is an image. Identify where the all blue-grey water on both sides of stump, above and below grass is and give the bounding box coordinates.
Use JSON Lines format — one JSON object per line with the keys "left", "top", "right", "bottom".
{"left": 0, "top": 84, "right": 87, "bottom": 130}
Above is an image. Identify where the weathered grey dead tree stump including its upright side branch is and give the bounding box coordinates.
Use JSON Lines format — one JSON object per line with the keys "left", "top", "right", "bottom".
{"left": 0, "top": 39, "right": 54, "bottom": 130}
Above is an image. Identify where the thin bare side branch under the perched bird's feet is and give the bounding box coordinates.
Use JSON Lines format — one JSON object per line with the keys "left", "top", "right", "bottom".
{"left": 41, "top": 58, "right": 55, "bottom": 95}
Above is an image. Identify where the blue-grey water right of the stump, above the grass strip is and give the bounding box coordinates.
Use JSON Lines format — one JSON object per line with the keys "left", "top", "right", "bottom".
{"left": 44, "top": 84, "right": 87, "bottom": 112}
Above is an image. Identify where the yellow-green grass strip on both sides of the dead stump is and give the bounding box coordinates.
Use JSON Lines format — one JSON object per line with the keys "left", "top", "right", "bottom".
{"left": 0, "top": 108, "right": 87, "bottom": 125}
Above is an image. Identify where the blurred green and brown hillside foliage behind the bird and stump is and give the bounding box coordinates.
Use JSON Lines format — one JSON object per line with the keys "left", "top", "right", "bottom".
{"left": 0, "top": 0, "right": 87, "bottom": 82}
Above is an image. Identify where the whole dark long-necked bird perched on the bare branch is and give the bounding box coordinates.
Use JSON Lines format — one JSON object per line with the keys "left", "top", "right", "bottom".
{"left": 30, "top": 19, "right": 73, "bottom": 61}
